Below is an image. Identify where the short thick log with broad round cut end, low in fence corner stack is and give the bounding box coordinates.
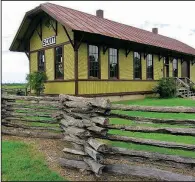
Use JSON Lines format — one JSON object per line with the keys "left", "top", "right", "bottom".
{"left": 87, "top": 138, "right": 108, "bottom": 152}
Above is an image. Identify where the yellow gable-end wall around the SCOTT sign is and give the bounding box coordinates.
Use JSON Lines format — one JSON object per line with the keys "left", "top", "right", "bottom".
{"left": 30, "top": 16, "right": 75, "bottom": 94}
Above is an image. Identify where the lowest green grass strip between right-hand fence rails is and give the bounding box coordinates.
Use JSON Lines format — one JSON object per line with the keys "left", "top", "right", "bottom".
{"left": 109, "top": 141, "right": 195, "bottom": 158}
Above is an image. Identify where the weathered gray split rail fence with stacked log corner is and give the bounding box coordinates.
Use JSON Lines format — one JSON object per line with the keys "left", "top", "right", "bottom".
{"left": 1, "top": 95, "right": 195, "bottom": 181}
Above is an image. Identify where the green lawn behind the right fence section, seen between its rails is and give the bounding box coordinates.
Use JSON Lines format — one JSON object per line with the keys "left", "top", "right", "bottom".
{"left": 109, "top": 98, "right": 195, "bottom": 158}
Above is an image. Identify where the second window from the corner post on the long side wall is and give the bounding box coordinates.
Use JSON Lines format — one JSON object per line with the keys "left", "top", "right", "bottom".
{"left": 109, "top": 48, "right": 118, "bottom": 78}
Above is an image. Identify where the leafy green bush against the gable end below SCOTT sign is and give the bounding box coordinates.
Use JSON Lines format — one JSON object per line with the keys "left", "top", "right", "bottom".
{"left": 26, "top": 72, "right": 47, "bottom": 96}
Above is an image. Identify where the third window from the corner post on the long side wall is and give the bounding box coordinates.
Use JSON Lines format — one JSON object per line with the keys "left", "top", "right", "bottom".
{"left": 133, "top": 52, "right": 142, "bottom": 79}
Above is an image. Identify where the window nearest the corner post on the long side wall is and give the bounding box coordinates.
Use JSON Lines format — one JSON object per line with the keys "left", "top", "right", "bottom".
{"left": 88, "top": 45, "right": 100, "bottom": 78}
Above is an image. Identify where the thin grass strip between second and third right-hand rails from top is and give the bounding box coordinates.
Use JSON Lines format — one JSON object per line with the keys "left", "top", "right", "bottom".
{"left": 110, "top": 118, "right": 195, "bottom": 128}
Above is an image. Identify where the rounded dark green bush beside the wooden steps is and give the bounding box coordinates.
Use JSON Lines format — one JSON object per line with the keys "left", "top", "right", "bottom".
{"left": 154, "top": 78, "right": 177, "bottom": 98}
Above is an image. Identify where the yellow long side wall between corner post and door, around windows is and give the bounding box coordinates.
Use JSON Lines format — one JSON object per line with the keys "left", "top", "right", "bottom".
{"left": 78, "top": 43, "right": 163, "bottom": 95}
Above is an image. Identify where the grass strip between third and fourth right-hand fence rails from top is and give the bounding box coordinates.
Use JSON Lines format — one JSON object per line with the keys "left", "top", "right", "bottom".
{"left": 108, "top": 130, "right": 195, "bottom": 145}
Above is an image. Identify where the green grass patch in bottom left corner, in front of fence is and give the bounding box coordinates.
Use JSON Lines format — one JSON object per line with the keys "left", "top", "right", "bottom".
{"left": 2, "top": 141, "right": 65, "bottom": 181}
